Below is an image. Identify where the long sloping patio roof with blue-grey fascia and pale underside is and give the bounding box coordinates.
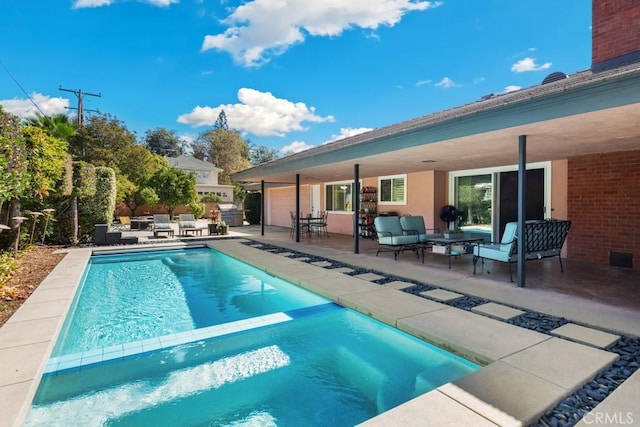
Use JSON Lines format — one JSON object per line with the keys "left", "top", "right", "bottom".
{"left": 233, "top": 63, "right": 640, "bottom": 184}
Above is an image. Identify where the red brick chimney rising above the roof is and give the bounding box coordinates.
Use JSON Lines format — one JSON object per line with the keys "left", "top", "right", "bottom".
{"left": 591, "top": 0, "right": 640, "bottom": 73}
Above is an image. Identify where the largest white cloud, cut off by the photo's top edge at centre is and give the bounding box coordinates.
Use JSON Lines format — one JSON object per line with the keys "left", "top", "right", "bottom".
{"left": 202, "top": 0, "right": 441, "bottom": 67}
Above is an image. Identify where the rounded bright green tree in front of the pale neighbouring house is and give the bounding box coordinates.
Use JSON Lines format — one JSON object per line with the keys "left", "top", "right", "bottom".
{"left": 148, "top": 168, "right": 197, "bottom": 215}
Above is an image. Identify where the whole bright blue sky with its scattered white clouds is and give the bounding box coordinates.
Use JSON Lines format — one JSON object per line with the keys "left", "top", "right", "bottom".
{"left": 0, "top": 0, "right": 591, "bottom": 154}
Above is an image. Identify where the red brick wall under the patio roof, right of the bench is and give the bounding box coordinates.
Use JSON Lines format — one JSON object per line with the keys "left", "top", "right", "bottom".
{"left": 567, "top": 150, "right": 640, "bottom": 270}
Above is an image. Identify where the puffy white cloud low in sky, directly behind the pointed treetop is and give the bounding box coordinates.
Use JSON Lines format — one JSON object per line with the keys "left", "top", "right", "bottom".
{"left": 178, "top": 88, "right": 334, "bottom": 136}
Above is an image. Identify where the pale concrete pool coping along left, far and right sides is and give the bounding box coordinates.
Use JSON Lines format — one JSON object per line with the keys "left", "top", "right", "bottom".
{"left": 0, "top": 239, "right": 639, "bottom": 426}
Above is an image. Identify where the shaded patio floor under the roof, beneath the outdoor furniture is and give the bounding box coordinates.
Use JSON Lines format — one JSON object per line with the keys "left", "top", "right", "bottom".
{"left": 239, "top": 226, "right": 640, "bottom": 316}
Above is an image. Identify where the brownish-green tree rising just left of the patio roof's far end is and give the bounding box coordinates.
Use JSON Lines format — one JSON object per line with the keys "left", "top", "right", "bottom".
{"left": 196, "top": 128, "right": 251, "bottom": 184}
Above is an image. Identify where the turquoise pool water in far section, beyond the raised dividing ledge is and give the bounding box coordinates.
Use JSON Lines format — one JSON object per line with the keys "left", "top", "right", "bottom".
{"left": 53, "top": 248, "right": 327, "bottom": 356}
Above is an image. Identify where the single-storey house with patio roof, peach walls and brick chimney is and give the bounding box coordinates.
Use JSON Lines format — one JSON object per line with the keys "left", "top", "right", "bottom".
{"left": 233, "top": 0, "right": 640, "bottom": 270}
